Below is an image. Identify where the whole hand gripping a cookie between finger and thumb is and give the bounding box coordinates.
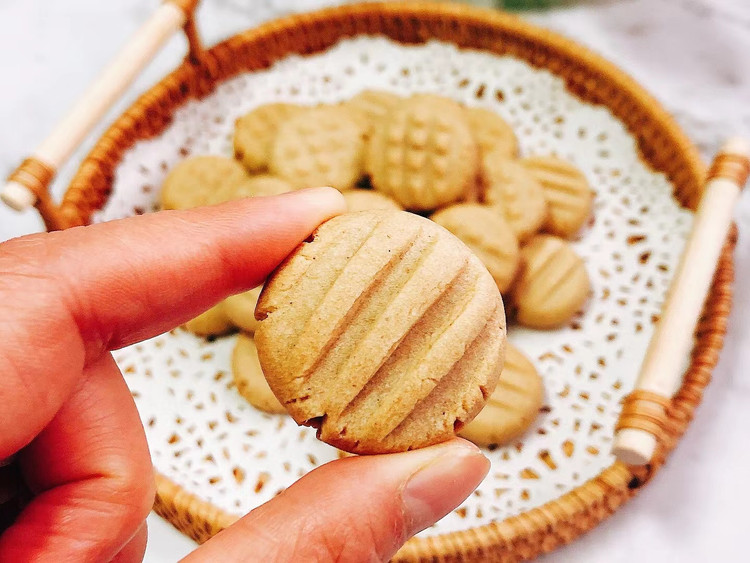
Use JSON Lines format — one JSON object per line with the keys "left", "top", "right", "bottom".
{"left": 0, "top": 188, "right": 488, "bottom": 562}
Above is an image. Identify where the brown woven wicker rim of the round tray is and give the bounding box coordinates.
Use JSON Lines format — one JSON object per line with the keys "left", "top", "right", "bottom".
{"left": 5, "top": 1, "right": 736, "bottom": 561}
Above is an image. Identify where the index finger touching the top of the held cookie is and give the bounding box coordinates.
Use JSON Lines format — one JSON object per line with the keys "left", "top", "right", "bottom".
{"left": 0, "top": 188, "right": 345, "bottom": 459}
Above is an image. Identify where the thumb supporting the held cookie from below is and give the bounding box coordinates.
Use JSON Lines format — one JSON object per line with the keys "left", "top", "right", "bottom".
{"left": 184, "top": 439, "right": 490, "bottom": 562}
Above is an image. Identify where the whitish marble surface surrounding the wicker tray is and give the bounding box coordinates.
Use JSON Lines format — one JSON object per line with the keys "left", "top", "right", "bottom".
{"left": 0, "top": 0, "right": 750, "bottom": 563}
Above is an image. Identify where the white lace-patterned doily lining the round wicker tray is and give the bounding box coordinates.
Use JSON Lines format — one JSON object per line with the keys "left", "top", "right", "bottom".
{"left": 94, "top": 37, "right": 692, "bottom": 535}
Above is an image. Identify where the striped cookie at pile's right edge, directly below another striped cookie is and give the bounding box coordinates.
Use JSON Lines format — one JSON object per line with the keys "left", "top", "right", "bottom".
{"left": 513, "top": 235, "right": 591, "bottom": 328}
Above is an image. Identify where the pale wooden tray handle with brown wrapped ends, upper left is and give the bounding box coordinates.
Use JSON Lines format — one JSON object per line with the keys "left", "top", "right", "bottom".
{"left": 0, "top": 0, "right": 203, "bottom": 230}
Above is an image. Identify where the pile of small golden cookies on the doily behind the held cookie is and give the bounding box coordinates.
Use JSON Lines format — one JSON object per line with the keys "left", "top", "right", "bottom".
{"left": 161, "top": 91, "right": 593, "bottom": 451}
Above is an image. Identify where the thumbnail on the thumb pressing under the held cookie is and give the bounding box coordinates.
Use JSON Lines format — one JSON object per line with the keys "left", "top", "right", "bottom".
{"left": 401, "top": 440, "right": 490, "bottom": 535}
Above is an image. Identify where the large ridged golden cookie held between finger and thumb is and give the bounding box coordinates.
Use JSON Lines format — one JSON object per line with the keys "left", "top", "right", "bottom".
{"left": 255, "top": 211, "right": 505, "bottom": 454}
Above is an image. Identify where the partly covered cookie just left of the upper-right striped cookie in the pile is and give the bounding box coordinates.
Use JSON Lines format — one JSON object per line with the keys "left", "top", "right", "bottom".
{"left": 481, "top": 152, "right": 547, "bottom": 242}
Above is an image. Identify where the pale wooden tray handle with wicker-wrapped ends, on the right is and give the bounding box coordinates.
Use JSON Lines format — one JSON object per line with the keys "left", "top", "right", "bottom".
{"left": 613, "top": 138, "right": 750, "bottom": 465}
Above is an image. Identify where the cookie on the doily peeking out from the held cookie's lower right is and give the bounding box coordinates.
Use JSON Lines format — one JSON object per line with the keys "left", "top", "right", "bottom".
{"left": 459, "top": 342, "right": 544, "bottom": 446}
